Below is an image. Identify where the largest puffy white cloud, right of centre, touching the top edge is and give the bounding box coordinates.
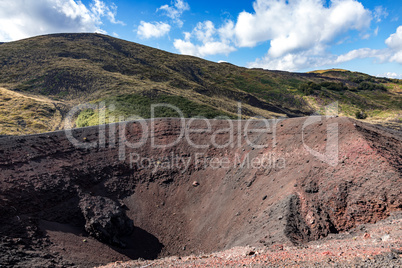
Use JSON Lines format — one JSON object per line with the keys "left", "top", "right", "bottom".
{"left": 240, "top": 0, "right": 372, "bottom": 71}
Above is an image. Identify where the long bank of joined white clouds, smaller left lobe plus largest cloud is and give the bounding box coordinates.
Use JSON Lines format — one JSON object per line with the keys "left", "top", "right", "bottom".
{"left": 174, "top": 0, "right": 380, "bottom": 71}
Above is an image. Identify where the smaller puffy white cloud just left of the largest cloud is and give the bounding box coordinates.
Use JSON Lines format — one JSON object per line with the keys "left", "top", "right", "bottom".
{"left": 173, "top": 21, "right": 236, "bottom": 57}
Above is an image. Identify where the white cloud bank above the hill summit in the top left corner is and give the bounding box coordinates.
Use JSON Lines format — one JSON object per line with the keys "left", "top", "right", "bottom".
{"left": 0, "top": 0, "right": 124, "bottom": 41}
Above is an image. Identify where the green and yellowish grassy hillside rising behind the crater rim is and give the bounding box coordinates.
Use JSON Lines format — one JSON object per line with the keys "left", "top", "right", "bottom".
{"left": 0, "top": 34, "right": 402, "bottom": 134}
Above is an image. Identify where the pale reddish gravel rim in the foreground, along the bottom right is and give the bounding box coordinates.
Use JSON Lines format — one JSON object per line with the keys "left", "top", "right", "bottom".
{"left": 102, "top": 213, "right": 402, "bottom": 268}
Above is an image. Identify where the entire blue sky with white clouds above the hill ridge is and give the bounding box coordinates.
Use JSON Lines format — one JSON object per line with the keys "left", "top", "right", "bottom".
{"left": 0, "top": 0, "right": 402, "bottom": 79}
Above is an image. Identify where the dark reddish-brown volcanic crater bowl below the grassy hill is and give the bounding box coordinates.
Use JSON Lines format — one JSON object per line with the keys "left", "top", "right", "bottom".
{"left": 0, "top": 117, "right": 402, "bottom": 267}
